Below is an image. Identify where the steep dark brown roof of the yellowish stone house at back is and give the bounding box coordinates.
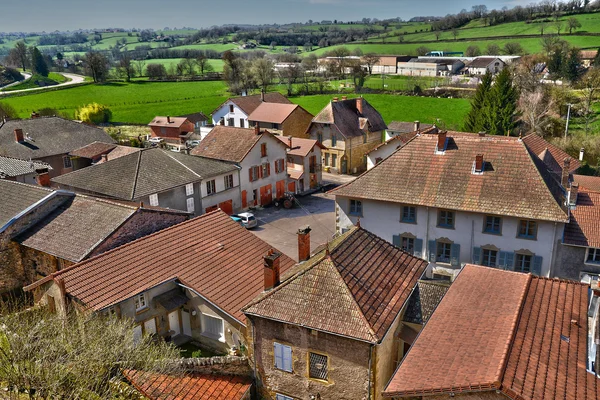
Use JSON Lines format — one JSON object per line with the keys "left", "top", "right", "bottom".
{"left": 312, "top": 97, "right": 387, "bottom": 138}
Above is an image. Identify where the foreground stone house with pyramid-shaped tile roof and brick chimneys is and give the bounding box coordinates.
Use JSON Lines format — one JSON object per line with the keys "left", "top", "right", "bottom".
{"left": 244, "top": 227, "right": 428, "bottom": 400}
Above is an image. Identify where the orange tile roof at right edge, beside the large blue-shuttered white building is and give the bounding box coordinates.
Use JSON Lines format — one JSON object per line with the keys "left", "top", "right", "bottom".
{"left": 563, "top": 190, "right": 600, "bottom": 248}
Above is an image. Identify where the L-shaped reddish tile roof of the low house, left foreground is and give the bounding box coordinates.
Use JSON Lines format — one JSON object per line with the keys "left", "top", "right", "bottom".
{"left": 28, "top": 211, "right": 294, "bottom": 323}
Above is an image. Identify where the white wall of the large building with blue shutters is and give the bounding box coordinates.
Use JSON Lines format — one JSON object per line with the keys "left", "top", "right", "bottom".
{"left": 336, "top": 196, "right": 564, "bottom": 276}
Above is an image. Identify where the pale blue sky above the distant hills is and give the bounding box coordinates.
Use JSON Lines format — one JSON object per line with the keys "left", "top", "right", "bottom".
{"left": 0, "top": 0, "right": 531, "bottom": 32}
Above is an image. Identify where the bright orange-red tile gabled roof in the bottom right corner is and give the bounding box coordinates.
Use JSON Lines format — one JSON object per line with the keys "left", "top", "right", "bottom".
{"left": 384, "top": 265, "right": 600, "bottom": 400}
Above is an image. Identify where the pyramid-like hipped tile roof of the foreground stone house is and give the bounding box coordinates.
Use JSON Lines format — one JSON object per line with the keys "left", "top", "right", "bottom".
{"left": 244, "top": 228, "right": 428, "bottom": 342}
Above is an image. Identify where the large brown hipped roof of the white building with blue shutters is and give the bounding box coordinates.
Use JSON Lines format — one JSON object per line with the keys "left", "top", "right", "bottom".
{"left": 331, "top": 132, "right": 567, "bottom": 222}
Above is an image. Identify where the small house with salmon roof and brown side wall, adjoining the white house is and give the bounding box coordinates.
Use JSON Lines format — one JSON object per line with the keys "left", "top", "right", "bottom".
{"left": 248, "top": 102, "right": 314, "bottom": 138}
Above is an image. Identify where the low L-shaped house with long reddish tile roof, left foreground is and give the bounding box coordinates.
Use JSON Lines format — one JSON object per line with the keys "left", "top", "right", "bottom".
{"left": 25, "top": 211, "right": 294, "bottom": 353}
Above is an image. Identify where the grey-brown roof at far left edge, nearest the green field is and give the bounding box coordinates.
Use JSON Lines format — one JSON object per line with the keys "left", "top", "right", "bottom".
{"left": 0, "top": 117, "right": 115, "bottom": 160}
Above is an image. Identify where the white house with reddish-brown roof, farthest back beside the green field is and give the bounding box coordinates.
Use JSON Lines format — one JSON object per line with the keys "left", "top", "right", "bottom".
{"left": 212, "top": 92, "right": 292, "bottom": 128}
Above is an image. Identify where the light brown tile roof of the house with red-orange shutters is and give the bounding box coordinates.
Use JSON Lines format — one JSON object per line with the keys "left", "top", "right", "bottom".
{"left": 191, "top": 125, "right": 287, "bottom": 162}
